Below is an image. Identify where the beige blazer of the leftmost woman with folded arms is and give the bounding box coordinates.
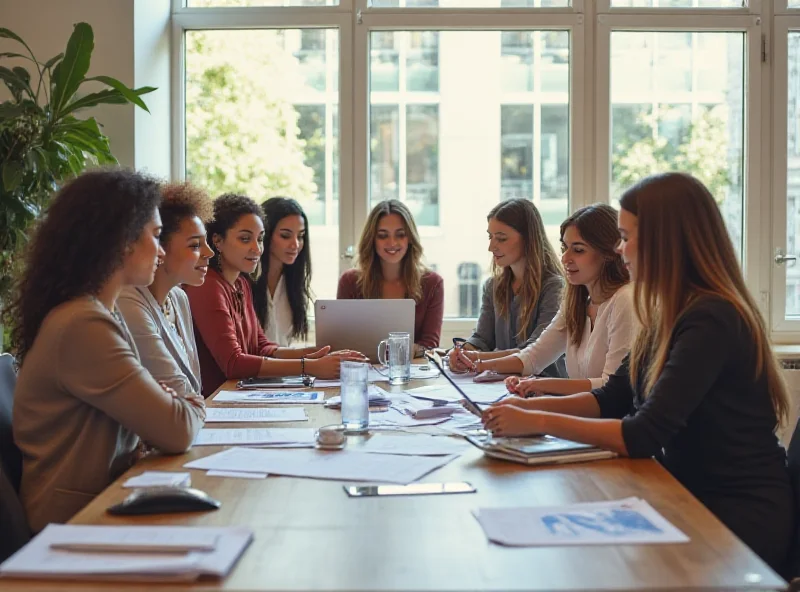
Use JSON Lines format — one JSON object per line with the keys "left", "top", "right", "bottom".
{"left": 13, "top": 297, "right": 204, "bottom": 532}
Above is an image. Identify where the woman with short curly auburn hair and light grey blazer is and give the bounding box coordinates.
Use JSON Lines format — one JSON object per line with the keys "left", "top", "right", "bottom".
{"left": 117, "top": 183, "right": 214, "bottom": 395}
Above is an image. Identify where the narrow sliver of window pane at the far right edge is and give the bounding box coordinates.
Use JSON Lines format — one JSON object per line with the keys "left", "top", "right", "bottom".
{"left": 785, "top": 31, "right": 800, "bottom": 320}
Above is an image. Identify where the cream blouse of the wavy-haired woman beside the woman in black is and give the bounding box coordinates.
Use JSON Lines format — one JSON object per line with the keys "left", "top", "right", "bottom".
{"left": 515, "top": 284, "right": 636, "bottom": 389}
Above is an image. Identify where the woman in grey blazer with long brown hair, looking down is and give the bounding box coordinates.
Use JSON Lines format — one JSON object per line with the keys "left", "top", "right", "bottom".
{"left": 449, "top": 199, "right": 567, "bottom": 377}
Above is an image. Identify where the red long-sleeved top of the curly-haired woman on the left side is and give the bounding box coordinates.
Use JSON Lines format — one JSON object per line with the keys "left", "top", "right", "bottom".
{"left": 184, "top": 268, "right": 278, "bottom": 397}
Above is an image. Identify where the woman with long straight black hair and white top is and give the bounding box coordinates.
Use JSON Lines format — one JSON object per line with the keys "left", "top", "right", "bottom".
{"left": 253, "top": 197, "right": 311, "bottom": 347}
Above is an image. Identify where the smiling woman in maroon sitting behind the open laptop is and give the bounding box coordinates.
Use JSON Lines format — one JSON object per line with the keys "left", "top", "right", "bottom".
{"left": 336, "top": 199, "right": 444, "bottom": 357}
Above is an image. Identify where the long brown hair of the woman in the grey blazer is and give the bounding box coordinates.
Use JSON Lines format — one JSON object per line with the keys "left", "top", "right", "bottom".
{"left": 486, "top": 199, "right": 563, "bottom": 340}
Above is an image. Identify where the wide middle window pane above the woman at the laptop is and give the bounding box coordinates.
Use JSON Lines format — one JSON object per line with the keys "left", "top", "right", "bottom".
{"left": 368, "top": 31, "right": 570, "bottom": 317}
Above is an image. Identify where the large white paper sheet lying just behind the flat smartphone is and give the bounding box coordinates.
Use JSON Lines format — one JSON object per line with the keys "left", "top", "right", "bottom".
{"left": 183, "top": 448, "right": 456, "bottom": 485}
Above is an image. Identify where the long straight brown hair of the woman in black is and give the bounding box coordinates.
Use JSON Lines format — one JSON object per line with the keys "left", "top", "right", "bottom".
{"left": 620, "top": 173, "right": 789, "bottom": 422}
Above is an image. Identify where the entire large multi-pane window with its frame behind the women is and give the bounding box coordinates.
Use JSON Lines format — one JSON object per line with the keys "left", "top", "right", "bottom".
{"left": 177, "top": 0, "right": 800, "bottom": 342}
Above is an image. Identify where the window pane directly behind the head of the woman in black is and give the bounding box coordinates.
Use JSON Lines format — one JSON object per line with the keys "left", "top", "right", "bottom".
{"left": 611, "top": 31, "right": 745, "bottom": 258}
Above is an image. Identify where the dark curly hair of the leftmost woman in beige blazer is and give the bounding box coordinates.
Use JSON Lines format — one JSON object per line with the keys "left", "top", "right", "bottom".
{"left": 4, "top": 169, "right": 161, "bottom": 363}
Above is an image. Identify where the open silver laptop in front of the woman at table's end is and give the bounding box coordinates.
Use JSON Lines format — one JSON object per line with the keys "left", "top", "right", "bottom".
{"left": 314, "top": 298, "right": 416, "bottom": 362}
